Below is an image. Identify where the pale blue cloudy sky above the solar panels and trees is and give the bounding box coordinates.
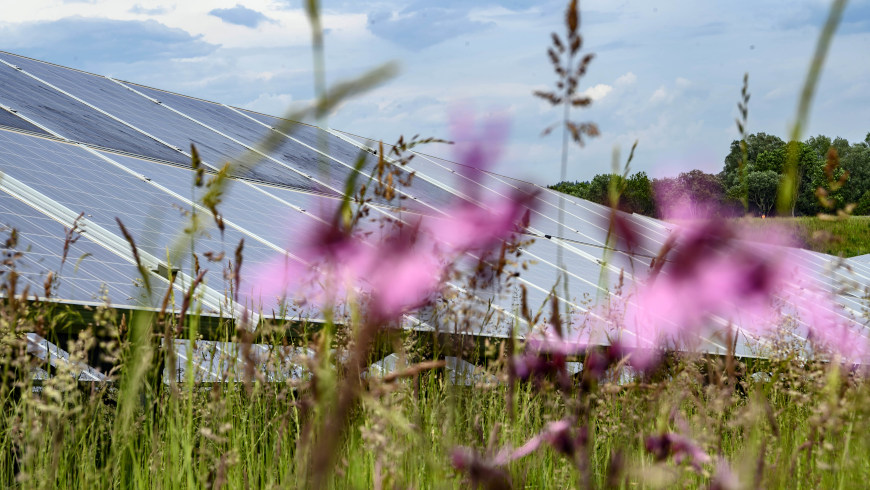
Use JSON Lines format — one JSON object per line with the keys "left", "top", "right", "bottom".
{"left": 0, "top": 0, "right": 870, "bottom": 184}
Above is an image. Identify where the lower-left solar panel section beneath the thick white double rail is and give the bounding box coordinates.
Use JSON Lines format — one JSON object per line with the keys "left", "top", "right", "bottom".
{"left": 0, "top": 192, "right": 167, "bottom": 307}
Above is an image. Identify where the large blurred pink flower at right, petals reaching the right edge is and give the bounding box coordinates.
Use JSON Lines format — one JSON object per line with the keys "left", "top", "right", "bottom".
{"left": 622, "top": 209, "right": 870, "bottom": 367}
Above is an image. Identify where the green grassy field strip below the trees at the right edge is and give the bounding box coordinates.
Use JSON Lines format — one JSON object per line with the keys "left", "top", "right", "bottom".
{"left": 739, "top": 216, "right": 870, "bottom": 257}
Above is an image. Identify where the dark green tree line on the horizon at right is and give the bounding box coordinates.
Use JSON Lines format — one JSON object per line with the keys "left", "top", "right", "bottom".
{"left": 550, "top": 133, "right": 870, "bottom": 217}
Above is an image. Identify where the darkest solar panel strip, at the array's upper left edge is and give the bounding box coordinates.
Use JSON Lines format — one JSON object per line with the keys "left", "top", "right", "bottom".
{"left": 0, "top": 59, "right": 184, "bottom": 161}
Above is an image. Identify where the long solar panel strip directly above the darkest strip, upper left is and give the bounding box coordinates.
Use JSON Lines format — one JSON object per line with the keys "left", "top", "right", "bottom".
{"left": 0, "top": 54, "right": 329, "bottom": 192}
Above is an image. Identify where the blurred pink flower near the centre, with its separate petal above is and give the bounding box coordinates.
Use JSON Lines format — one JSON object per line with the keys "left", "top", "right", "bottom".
{"left": 252, "top": 112, "right": 535, "bottom": 322}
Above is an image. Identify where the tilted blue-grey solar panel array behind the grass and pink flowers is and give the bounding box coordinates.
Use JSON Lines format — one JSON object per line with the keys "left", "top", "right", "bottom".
{"left": 0, "top": 52, "right": 870, "bottom": 362}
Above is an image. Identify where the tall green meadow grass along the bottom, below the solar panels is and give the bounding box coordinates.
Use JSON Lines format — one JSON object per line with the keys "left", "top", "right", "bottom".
{"left": 0, "top": 322, "right": 870, "bottom": 489}
